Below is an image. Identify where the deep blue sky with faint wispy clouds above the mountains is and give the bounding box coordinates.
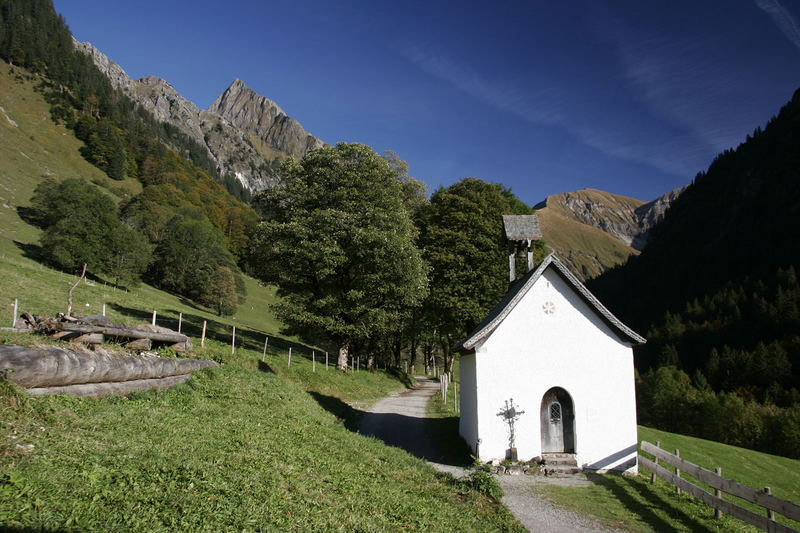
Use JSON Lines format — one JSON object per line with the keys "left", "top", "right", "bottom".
{"left": 54, "top": 0, "right": 800, "bottom": 205}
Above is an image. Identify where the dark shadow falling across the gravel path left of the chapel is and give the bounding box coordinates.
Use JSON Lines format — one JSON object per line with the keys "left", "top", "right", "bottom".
{"left": 310, "top": 382, "right": 471, "bottom": 466}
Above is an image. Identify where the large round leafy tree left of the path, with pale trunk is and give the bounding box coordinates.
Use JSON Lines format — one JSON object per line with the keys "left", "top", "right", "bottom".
{"left": 251, "top": 143, "right": 426, "bottom": 370}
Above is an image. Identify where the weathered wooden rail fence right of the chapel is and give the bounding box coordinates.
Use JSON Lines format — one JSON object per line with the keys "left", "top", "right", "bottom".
{"left": 639, "top": 441, "right": 800, "bottom": 533}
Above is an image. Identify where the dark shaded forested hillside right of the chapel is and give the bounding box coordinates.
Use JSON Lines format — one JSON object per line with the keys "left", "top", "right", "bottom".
{"left": 590, "top": 91, "right": 800, "bottom": 456}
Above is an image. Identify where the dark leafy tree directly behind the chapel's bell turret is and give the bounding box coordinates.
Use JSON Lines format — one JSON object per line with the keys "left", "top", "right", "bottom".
{"left": 420, "top": 178, "right": 541, "bottom": 368}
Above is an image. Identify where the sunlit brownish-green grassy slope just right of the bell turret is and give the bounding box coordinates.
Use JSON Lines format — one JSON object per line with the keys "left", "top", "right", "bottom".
{"left": 536, "top": 206, "right": 639, "bottom": 280}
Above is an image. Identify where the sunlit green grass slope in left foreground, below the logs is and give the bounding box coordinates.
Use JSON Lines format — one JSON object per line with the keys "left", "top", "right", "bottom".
{"left": 0, "top": 347, "right": 519, "bottom": 531}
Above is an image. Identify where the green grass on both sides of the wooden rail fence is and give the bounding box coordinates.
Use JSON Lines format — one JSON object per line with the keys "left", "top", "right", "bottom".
{"left": 524, "top": 426, "right": 800, "bottom": 531}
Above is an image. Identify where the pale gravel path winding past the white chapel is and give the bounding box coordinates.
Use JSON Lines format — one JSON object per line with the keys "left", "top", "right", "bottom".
{"left": 359, "top": 377, "right": 603, "bottom": 533}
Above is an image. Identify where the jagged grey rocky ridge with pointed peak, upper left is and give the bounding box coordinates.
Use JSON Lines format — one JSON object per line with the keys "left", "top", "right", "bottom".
{"left": 73, "top": 38, "right": 324, "bottom": 192}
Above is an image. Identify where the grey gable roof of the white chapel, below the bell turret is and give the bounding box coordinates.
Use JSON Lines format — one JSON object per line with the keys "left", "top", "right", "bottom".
{"left": 453, "top": 252, "right": 647, "bottom": 350}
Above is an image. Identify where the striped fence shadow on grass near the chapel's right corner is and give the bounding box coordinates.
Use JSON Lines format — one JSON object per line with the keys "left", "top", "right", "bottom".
{"left": 587, "top": 474, "right": 714, "bottom": 533}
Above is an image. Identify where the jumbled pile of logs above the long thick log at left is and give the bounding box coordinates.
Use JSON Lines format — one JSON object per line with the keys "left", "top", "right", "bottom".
{"left": 17, "top": 313, "right": 192, "bottom": 353}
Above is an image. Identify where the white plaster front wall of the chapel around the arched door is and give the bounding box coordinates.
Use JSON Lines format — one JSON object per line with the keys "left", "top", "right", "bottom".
{"left": 476, "top": 268, "right": 637, "bottom": 470}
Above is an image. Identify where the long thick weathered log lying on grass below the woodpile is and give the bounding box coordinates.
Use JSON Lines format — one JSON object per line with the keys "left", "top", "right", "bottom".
{"left": 0, "top": 345, "right": 217, "bottom": 387}
